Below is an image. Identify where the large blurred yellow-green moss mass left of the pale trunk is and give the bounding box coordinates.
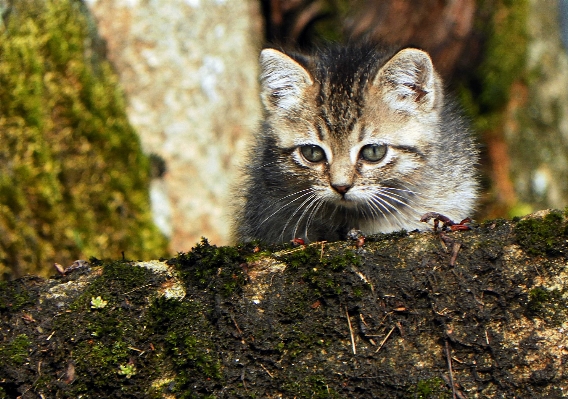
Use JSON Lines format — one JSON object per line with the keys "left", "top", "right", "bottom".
{"left": 0, "top": 0, "right": 167, "bottom": 277}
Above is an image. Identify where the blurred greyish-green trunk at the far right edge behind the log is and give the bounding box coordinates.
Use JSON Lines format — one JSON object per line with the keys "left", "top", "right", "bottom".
{"left": 504, "top": 0, "right": 568, "bottom": 214}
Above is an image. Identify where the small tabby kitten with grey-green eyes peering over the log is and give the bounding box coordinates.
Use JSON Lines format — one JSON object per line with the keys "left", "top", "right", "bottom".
{"left": 235, "top": 45, "right": 478, "bottom": 243}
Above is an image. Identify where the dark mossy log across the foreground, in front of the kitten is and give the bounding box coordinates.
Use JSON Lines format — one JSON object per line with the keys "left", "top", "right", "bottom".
{"left": 0, "top": 211, "right": 568, "bottom": 398}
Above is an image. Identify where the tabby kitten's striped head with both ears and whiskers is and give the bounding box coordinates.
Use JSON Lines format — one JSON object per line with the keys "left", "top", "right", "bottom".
{"left": 260, "top": 48, "right": 443, "bottom": 222}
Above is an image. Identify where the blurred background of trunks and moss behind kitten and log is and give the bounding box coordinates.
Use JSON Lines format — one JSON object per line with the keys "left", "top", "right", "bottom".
{"left": 0, "top": 0, "right": 568, "bottom": 278}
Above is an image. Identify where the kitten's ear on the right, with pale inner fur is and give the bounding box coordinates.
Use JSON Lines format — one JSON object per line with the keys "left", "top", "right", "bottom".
{"left": 373, "top": 48, "right": 442, "bottom": 114}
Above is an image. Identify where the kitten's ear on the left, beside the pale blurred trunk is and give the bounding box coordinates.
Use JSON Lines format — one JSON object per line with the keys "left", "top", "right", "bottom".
{"left": 260, "top": 49, "right": 313, "bottom": 111}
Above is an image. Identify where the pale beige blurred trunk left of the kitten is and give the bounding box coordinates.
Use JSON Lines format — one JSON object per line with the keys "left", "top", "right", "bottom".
{"left": 86, "top": 0, "right": 262, "bottom": 251}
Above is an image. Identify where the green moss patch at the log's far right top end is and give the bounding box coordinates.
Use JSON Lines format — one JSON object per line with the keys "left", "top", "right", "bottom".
{"left": 514, "top": 210, "right": 568, "bottom": 255}
